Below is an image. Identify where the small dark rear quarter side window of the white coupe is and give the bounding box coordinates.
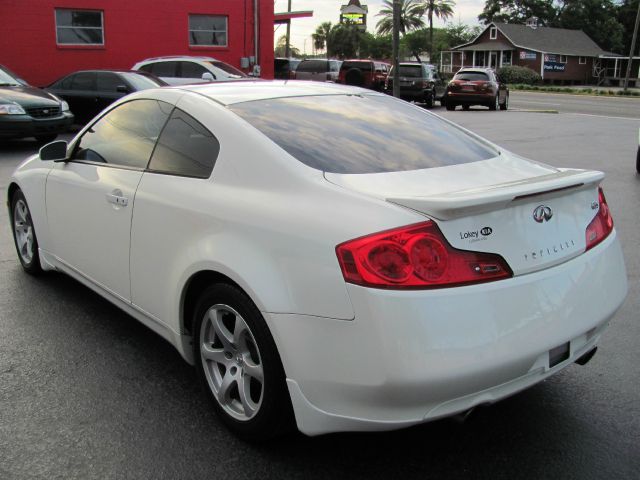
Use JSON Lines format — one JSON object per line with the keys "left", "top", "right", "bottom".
{"left": 149, "top": 108, "right": 220, "bottom": 178}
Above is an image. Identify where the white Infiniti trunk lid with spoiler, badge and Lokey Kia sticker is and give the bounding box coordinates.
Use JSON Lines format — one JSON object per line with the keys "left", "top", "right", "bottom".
{"left": 325, "top": 152, "right": 604, "bottom": 275}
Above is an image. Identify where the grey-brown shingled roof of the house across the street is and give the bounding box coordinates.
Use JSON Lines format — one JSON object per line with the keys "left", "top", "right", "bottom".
{"left": 455, "top": 22, "right": 604, "bottom": 57}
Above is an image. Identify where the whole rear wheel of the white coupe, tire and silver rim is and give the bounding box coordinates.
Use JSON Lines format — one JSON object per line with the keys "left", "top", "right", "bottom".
{"left": 192, "top": 283, "right": 294, "bottom": 442}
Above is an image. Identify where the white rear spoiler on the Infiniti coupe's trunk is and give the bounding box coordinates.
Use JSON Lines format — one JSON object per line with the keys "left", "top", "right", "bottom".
{"left": 386, "top": 169, "right": 604, "bottom": 220}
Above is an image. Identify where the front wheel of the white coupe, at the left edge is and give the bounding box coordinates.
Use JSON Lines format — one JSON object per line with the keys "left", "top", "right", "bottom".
{"left": 10, "top": 190, "right": 42, "bottom": 275}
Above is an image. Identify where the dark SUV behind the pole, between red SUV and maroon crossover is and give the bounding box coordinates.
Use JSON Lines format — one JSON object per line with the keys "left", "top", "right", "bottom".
{"left": 385, "top": 62, "right": 445, "bottom": 108}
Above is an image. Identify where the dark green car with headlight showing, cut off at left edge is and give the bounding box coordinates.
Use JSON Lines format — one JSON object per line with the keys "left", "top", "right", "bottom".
{"left": 0, "top": 65, "right": 73, "bottom": 143}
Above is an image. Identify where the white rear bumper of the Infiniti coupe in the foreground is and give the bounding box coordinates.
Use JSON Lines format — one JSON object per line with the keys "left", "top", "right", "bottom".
{"left": 265, "top": 232, "right": 627, "bottom": 435}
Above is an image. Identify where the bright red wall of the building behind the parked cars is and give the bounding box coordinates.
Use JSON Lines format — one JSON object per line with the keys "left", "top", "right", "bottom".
{"left": 0, "top": 0, "right": 273, "bottom": 86}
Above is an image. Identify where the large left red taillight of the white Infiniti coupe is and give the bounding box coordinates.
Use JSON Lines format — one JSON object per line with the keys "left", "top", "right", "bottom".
{"left": 336, "top": 221, "right": 513, "bottom": 289}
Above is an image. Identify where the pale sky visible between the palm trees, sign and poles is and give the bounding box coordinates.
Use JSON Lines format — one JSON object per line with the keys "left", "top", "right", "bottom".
{"left": 274, "top": 0, "right": 485, "bottom": 54}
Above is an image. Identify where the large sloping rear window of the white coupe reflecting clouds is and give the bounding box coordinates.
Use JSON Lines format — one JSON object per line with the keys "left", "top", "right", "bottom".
{"left": 231, "top": 95, "right": 497, "bottom": 173}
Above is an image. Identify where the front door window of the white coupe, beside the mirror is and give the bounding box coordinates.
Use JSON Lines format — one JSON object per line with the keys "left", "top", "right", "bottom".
{"left": 72, "top": 100, "right": 173, "bottom": 169}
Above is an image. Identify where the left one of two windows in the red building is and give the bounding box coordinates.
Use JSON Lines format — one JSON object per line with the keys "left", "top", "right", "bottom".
{"left": 56, "top": 9, "right": 104, "bottom": 45}
